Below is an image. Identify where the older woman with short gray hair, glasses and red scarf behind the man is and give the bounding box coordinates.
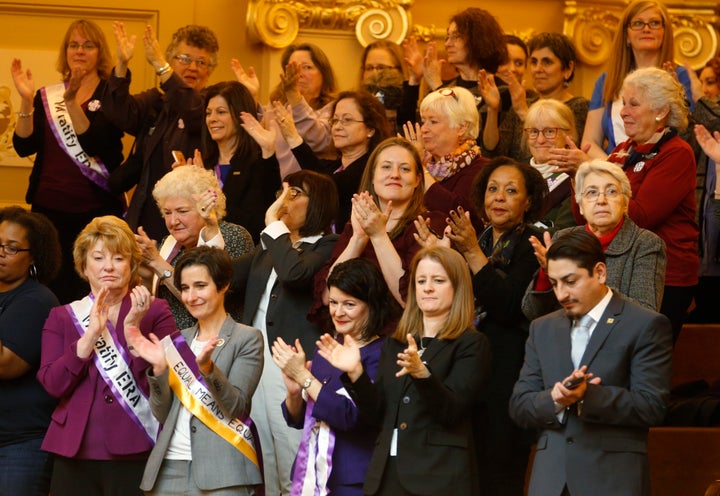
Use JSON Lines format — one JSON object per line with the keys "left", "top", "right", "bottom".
{"left": 522, "top": 160, "right": 666, "bottom": 320}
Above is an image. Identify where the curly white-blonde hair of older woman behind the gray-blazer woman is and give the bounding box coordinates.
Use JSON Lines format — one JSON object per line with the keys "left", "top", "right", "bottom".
{"left": 153, "top": 165, "right": 226, "bottom": 220}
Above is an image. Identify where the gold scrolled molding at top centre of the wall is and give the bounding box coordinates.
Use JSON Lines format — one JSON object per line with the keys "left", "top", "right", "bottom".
{"left": 247, "top": 0, "right": 414, "bottom": 48}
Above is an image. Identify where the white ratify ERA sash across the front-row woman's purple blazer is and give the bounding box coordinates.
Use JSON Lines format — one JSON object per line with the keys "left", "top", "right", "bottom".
{"left": 66, "top": 296, "right": 160, "bottom": 444}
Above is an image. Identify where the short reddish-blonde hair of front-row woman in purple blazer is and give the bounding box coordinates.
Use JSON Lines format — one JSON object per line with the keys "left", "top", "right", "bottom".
{"left": 73, "top": 215, "right": 142, "bottom": 287}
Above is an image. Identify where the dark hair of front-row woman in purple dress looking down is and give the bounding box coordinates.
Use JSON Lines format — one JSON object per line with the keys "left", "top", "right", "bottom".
{"left": 327, "top": 258, "right": 400, "bottom": 340}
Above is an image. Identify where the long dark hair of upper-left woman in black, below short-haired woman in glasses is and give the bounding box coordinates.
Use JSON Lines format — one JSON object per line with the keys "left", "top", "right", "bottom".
{"left": 201, "top": 81, "right": 260, "bottom": 166}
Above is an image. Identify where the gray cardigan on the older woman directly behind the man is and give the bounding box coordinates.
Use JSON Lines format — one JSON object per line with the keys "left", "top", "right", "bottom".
{"left": 522, "top": 216, "right": 666, "bottom": 320}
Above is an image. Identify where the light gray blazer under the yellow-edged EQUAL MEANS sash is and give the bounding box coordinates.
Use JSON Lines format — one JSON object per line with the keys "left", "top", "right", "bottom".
{"left": 140, "top": 316, "right": 262, "bottom": 491}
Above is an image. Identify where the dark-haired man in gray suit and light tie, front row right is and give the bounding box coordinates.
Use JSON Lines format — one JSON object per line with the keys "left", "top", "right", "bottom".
{"left": 510, "top": 231, "right": 672, "bottom": 496}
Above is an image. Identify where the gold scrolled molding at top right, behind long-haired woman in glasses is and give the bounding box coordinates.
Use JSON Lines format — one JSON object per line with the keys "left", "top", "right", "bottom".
{"left": 563, "top": 0, "right": 720, "bottom": 69}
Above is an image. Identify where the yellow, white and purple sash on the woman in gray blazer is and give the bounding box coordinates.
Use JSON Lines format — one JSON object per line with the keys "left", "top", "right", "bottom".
{"left": 161, "top": 334, "right": 259, "bottom": 466}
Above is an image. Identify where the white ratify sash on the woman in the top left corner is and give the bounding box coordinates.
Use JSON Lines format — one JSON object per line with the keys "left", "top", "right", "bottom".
{"left": 40, "top": 83, "right": 110, "bottom": 191}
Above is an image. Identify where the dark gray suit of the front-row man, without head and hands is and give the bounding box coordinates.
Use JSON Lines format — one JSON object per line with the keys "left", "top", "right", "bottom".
{"left": 510, "top": 293, "right": 672, "bottom": 496}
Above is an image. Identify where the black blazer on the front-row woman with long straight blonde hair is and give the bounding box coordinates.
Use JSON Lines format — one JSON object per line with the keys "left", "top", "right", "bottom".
{"left": 341, "top": 329, "right": 490, "bottom": 496}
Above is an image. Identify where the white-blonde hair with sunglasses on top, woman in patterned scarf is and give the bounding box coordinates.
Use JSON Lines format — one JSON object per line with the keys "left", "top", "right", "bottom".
{"left": 420, "top": 86, "right": 480, "bottom": 140}
